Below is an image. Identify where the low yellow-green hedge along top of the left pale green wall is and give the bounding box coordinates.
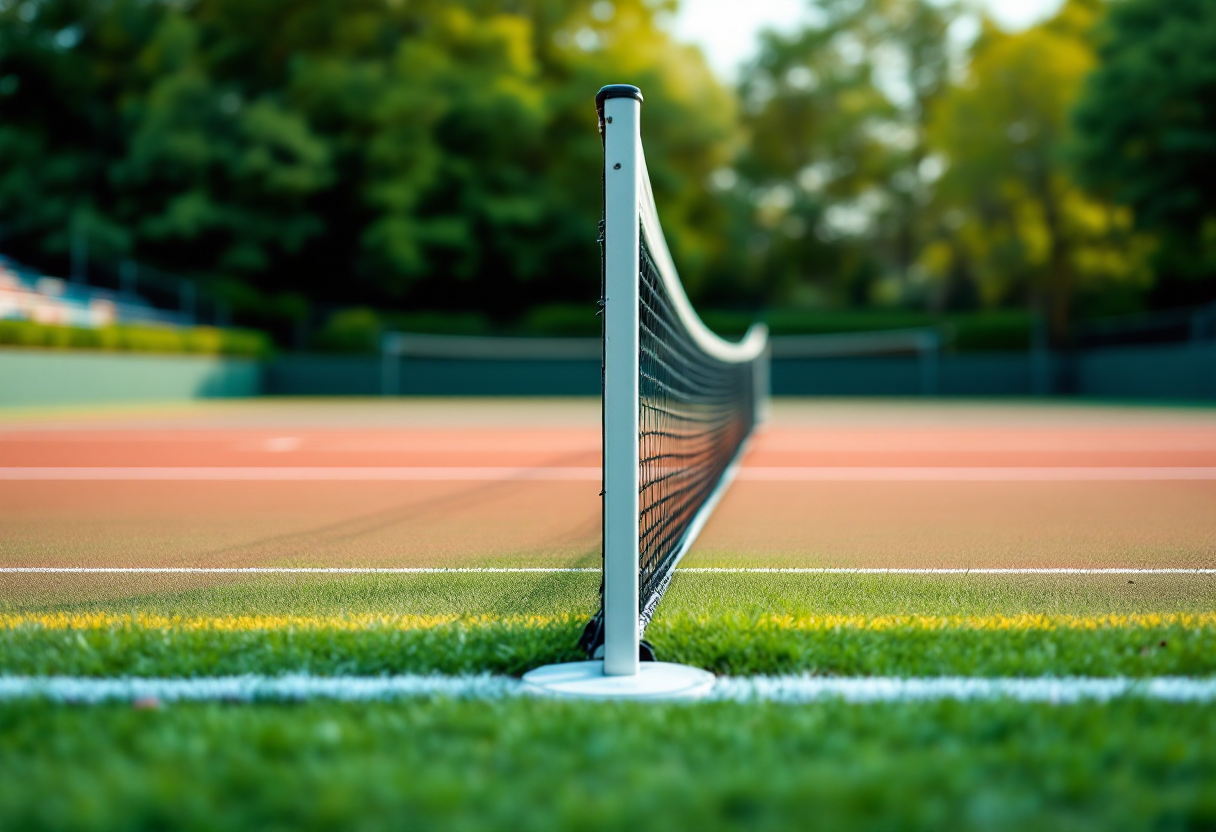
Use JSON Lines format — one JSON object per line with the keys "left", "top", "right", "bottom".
{"left": 0, "top": 321, "right": 271, "bottom": 358}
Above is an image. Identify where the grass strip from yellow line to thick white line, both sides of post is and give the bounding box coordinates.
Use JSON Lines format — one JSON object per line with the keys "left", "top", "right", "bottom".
{"left": 0, "top": 614, "right": 1216, "bottom": 676}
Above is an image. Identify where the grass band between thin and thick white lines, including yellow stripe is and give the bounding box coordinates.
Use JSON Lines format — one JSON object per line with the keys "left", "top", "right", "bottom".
{"left": 0, "top": 573, "right": 1216, "bottom": 676}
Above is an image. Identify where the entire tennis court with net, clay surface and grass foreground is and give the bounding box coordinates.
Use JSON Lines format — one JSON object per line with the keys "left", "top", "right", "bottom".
{"left": 0, "top": 76, "right": 1216, "bottom": 830}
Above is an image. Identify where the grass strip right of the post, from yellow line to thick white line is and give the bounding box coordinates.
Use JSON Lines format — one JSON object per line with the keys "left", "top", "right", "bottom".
{"left": 649, "top": 615, "right": 1216, "bottom": 676}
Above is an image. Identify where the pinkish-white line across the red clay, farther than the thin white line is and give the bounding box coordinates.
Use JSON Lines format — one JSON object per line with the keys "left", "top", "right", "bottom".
{"left": 7, "top": 466, "right": 1216, "bottom": 483}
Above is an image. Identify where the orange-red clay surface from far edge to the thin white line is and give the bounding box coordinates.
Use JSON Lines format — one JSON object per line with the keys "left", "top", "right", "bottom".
{"left": 0, "top": 400, "right": 1216, "bottom": 578}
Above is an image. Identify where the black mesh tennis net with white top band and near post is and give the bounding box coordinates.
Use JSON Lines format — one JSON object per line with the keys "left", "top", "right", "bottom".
{"left": 582, "top": 85, "right": 769, "bottom": 675}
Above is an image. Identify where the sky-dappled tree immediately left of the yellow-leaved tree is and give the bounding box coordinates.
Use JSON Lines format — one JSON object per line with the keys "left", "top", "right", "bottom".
{"left": 719, "top": 6, "right": 893, "bottom": 304}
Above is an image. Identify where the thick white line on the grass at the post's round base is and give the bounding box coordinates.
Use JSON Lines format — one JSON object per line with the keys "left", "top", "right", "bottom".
{"left": 0, "top": 674, "right": 1216, "bottom": 704}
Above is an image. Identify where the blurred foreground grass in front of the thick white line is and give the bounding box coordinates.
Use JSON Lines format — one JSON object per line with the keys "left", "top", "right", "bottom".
{"left": 0, "top": 699, "right": 1216, "bottom": 832}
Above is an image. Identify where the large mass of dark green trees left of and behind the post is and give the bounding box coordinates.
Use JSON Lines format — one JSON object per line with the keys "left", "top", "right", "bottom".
{"left": 0, "top": 0, "right": 732, "bottom": 318}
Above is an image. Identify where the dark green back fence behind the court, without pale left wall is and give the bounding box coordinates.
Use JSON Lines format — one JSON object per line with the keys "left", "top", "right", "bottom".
{"left": 266, "top": 330, "right": 1216, "bottom": 399}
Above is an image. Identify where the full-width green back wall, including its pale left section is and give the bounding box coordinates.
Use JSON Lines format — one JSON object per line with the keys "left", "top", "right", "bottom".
{"left": 0, "top": 316, "right": 1216, "bottom": 405}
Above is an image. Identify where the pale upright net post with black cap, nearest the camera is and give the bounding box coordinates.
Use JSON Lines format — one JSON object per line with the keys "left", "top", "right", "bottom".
{"left": 597, "top": 86, "right": 641, "bottom": 676}
